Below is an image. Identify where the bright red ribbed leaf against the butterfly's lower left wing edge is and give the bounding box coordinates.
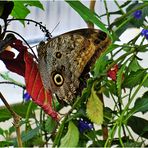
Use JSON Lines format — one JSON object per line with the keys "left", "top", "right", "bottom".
{"left": 24, "top": 52, "right": 59, "bottom": 120}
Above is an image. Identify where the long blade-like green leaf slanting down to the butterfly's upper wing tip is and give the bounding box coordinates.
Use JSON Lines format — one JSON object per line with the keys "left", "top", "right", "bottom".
{"left": 65, "top": 0, "right": 109, "bottom": 35}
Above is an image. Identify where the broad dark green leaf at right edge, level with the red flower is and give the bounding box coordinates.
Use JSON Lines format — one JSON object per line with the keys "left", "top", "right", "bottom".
{"left": 123, "top": 69, "right": 146, "bottom": 88}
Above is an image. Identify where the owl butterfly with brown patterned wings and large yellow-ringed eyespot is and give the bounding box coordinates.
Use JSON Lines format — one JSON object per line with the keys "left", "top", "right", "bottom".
{"left": 38, "top": 28, "right": 110, "bottom": 103}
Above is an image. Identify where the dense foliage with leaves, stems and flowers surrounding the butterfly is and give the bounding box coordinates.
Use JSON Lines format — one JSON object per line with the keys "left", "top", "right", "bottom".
{"left": 0, "top": 0, "right": 148, "bottom": 147}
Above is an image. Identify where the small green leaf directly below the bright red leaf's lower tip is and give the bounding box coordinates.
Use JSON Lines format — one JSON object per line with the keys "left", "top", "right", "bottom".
{"left": 45, "top": 117, "right": 57, "bottom": 133}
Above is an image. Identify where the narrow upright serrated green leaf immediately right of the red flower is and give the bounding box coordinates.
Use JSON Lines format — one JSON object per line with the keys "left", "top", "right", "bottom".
{"left": 116, "top": 63, "right": 126, "bottom": 96}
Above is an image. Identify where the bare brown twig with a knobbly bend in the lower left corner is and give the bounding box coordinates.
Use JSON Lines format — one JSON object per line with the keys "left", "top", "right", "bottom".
{"left": 0, "top": 92, "right": 23, "bottom": 147}
